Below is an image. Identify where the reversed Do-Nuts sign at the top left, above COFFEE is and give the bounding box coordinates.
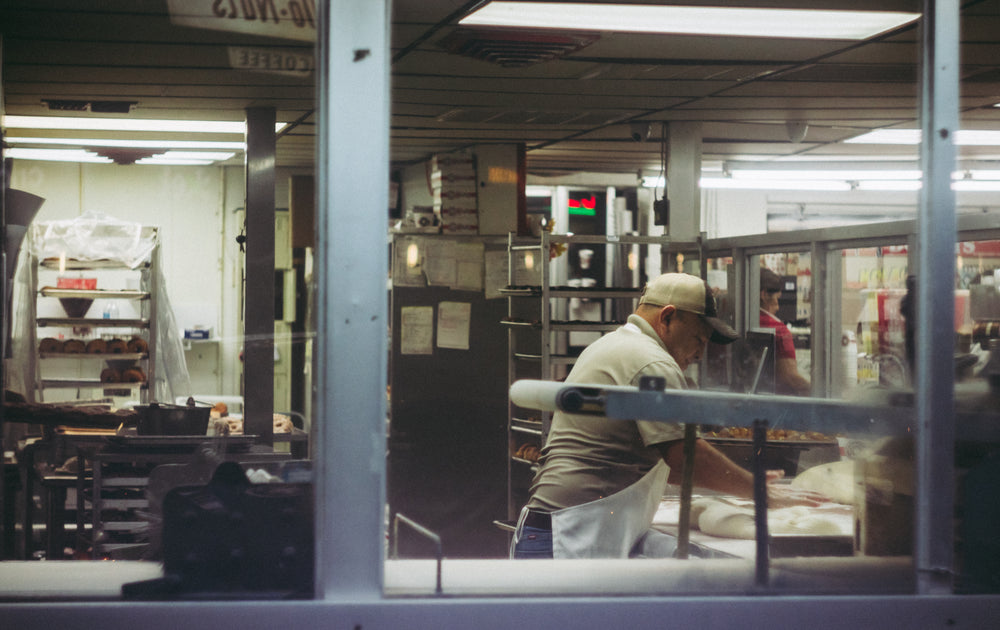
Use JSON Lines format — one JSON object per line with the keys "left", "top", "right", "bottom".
{"left": 167, "top": 0, "right": 316, "bottom": 42}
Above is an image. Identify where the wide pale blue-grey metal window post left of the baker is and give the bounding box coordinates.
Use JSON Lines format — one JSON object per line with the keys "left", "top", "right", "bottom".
{"left": 314, "top": 0, "right": 390, "bottom": 602}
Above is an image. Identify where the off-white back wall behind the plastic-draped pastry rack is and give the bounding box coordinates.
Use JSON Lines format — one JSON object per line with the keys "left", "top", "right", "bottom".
{"left": 11, "top": 160, "right": 310, "bottom": 402}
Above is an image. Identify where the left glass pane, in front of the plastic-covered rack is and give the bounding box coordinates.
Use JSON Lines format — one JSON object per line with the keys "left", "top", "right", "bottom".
{"left": 0, "top": 3, "right": 317, "bottom": 599}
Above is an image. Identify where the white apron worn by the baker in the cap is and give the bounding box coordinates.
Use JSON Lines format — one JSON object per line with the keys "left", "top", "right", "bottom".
{"left": 518, "top": 461, "right": 670, "bottom": 558}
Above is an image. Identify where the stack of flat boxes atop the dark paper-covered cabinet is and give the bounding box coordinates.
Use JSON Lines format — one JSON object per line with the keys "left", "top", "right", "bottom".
{"left": 430, "top": 153, "right": 479, "bottom": 235}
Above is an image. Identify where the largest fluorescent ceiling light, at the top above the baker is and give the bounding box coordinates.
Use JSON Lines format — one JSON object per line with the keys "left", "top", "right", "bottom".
{"left": 459, "top": 1, "right": 920, "bottom": 40}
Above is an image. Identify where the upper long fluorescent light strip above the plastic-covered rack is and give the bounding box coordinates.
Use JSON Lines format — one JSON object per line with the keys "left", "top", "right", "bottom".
{"left": 3, "top": 116, "right": 288, "bottom": 134}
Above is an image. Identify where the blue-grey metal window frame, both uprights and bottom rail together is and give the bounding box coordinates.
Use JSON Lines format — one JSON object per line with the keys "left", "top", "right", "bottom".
{"left": 0, "top": 0, "right": 1000, "bottom": 630}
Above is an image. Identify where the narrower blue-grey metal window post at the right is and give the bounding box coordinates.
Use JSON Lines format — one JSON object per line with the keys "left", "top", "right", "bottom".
{"left": 914, "top": 0, "right": 959, "bottom": 594}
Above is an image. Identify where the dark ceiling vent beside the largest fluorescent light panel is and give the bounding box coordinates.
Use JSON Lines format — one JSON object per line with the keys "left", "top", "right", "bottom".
{"left": 438, "top": 28, "right": 601, "bottom": 68}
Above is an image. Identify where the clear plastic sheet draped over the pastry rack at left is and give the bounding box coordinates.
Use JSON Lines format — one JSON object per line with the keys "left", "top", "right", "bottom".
{"left": 6, "top": 212, "right": 192, "bottom": 402}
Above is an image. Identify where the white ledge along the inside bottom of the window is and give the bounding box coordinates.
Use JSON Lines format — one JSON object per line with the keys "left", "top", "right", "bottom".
{"left": 0, "top": 557, "right": 914, "bottom": 601}
